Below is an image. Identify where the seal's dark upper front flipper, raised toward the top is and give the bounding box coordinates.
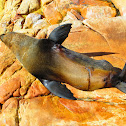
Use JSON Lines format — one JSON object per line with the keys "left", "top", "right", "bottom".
{"left": 48, "top": 23, "right": 72, "bottom": 44}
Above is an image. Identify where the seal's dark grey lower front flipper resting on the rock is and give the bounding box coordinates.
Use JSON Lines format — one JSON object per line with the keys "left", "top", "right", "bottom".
{"left": 41, "top": 80, "right": 76, "bottom": 100}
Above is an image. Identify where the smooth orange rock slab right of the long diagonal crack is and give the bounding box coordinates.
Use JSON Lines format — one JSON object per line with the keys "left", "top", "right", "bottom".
{"left": 84, "top": 16, "right": 126, "bottom": 67}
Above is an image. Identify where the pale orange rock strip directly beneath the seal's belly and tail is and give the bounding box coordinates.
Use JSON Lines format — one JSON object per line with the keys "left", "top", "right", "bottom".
{"left": 66, "top": 84, "right": 126, "bottom": 103}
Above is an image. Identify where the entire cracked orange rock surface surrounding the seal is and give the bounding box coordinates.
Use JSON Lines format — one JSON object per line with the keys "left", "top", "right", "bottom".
{"left": 0, "top": 0, "right": 126, "bottom": 126}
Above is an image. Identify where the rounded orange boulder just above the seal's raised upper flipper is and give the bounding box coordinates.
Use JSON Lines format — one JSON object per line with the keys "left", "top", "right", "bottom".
{"left": 43, "top": 1, "right": 63, "bottom": 24}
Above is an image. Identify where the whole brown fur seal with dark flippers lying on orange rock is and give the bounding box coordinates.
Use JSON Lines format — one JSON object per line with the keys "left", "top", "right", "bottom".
{"left": 0, "top": 24, "right": 126, "bottom": 100}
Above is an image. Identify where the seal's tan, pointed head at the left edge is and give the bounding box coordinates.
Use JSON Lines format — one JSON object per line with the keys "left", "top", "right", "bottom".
{"left": 0, "top": 32, "right": 38, "bottom": 56}
